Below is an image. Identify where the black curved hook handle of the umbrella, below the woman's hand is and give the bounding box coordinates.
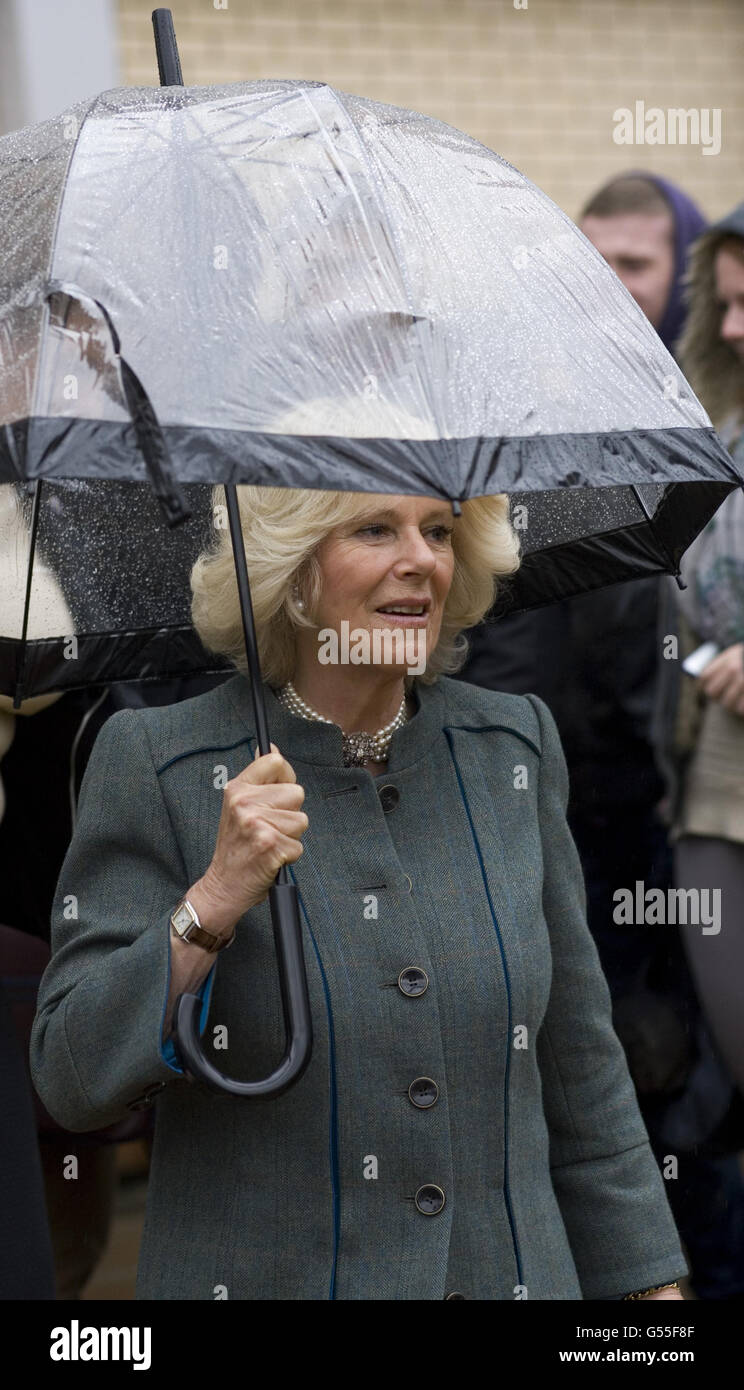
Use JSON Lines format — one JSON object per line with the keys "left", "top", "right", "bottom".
{"left": 171, "top": 867, "right": 313, "bottom": 1097}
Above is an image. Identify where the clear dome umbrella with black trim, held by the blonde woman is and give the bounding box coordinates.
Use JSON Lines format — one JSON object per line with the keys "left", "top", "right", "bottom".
{"left": 0, "top": 11, "right": 743, "bottom": 1095}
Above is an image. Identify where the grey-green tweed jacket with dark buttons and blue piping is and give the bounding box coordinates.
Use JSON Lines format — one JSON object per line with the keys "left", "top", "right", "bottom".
{"left": 31, "top": 676, "right": 687, "bottom": 1300}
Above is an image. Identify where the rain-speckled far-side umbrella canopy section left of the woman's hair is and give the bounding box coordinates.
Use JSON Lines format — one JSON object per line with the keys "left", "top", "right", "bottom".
{"left": 0, "top": 480, "right": 231, "bottom": 698}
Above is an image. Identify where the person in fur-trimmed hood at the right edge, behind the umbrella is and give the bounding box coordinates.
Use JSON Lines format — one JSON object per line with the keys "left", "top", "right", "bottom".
{"left": 655, "top": 202, "right": 744, "bottom": 1095}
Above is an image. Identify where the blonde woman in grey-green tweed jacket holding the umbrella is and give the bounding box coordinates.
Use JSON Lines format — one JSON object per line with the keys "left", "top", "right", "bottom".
{"left": 32, "top": 488, "right": 686, "bottom": 1300}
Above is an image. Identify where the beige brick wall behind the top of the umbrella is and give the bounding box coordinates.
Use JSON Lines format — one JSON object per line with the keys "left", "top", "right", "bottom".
{"left": 118, "top": 0, "right": 744, "bottom": 218}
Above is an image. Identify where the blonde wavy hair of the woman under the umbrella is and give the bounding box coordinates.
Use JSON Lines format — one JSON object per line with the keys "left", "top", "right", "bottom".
{"left": 191, "top": 485, "right": 520, "bottom": 687}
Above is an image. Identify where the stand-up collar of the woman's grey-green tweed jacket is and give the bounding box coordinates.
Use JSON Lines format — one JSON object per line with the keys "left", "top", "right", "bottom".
{"left": 225, "top": 671, "right": 446, "bottom": 773}
